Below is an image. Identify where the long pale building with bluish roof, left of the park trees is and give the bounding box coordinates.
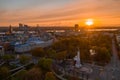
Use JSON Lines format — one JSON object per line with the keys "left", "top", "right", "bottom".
{"left": 15, "top": 37, "right": 53, "bottom": 53}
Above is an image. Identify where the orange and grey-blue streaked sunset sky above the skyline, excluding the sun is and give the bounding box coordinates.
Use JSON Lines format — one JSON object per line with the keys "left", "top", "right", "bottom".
{"left": 0, "top": 0, "right": 120, "bottom": 26}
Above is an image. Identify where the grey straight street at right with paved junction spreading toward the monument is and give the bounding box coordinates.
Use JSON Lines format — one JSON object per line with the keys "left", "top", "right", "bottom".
{"left": 92, "top": 39, "right": 120, "bottom": 80}
